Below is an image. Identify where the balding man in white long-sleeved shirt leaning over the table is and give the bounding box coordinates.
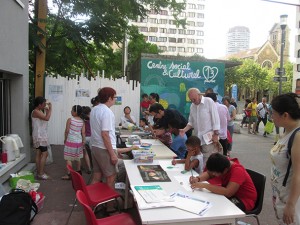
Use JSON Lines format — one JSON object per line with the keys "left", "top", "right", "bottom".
{"left": 180, "top": 88, "right": 223, "bottom": 165}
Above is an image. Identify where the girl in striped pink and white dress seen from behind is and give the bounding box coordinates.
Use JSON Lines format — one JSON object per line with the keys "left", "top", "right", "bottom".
{"left": 62, "top": 105, "right": 85, "bottom": 180}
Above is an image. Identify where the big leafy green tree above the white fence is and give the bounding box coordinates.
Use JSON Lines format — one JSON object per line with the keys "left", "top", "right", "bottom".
{"left": 29, "top": 0, "right": 185, "bottom": 75}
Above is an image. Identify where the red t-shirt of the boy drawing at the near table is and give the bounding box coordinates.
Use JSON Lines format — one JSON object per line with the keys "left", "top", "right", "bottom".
{"left": 209, "top": 158, "right": 257, "bottom": 211}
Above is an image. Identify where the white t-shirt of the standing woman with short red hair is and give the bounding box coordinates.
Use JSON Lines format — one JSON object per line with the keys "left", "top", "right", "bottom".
{"left": 90, "top": 104, "right": 116, "bottom": 149}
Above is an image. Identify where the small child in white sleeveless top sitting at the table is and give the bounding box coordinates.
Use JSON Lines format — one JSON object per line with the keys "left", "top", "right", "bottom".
{"left": 172, "top": 136, "right": 203, "bottom": 174}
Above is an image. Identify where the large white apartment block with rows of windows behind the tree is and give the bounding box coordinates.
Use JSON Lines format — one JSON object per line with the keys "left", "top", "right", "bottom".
{"left": 132, "top": 0, "right": 205, "bottom": 56}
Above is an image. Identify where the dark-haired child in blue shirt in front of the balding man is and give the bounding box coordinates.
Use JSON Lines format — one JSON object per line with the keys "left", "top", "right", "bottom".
{"left": 168, "top": 119, "right": 187, "bottom": 159}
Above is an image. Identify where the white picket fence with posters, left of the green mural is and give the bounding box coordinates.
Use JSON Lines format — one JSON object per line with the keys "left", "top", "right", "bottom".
{"left": 45, "top": 75, "right": 140, "bottom": 144}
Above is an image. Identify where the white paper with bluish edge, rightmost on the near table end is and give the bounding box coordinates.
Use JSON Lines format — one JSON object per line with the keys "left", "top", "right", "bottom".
{"left": 171, "top": 191, "right": 211, "bottom": 216}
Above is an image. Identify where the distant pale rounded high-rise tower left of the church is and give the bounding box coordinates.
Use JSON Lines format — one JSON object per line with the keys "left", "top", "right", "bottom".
{"left": 226, "top": 26, "right": 250, "bottom": 55}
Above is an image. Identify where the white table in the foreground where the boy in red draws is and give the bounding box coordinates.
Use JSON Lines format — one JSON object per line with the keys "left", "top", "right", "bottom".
{"left": 124, "top": 160, "right": 245, "bottom": 225}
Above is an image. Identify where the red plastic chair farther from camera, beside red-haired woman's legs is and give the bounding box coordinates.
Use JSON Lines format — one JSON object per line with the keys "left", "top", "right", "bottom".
{"left": 67, "top": 165, "right": 121, "bottom": 211}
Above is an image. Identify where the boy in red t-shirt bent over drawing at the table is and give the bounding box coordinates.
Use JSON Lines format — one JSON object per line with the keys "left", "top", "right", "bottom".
{"left": 190, "top": 153, "right": 257, "bottom": 211}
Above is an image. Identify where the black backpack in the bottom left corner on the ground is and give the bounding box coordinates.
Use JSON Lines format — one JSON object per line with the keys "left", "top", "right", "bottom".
{"left": 0, "top": 189, "right": 38, "bottom": 225}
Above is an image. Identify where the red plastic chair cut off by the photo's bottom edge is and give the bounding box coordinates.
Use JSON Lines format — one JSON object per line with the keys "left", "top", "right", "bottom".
{"left": 76, "top": 190, "right": 136, "bottom": 225}
